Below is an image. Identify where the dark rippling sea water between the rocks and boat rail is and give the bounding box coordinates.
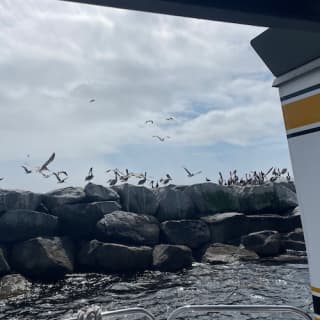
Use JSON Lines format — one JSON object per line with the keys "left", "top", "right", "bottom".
{"left": 0, "top": 263, "right": 312, "bottom": 320}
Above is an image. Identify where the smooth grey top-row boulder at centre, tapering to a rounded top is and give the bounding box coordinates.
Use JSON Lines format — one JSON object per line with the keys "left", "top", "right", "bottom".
{"left": 156, "top": 186, "right": 198, "bottom": 221}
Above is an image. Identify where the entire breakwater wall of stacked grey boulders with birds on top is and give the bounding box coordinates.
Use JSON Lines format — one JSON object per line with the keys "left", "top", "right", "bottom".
{"left": 0, "top": 183, "right": 306, "bottom": 286}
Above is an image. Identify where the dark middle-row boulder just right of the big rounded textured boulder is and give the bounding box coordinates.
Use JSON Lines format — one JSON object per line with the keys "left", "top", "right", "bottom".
{"left": 161, "top": 220, "right": 210, "bottom": 249}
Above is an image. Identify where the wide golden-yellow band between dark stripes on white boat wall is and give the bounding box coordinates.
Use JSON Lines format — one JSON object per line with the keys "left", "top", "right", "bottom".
{"left": 282, "top": 94, "right": 320, "bottom": 130}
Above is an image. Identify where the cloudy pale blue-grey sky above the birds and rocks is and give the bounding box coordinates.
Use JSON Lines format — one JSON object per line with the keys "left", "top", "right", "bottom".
{"left": 0, "top": 0, "right": 291, "bottom": 192}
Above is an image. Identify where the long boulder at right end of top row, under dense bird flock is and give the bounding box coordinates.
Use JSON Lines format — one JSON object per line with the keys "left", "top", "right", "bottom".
{"left": 236, "top": 183, "right": 298, "bottom": 214}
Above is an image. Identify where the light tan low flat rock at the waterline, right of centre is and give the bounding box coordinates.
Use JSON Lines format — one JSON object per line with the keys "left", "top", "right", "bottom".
{"left": 202, "top": 243, "right": 259, "bottom": 264}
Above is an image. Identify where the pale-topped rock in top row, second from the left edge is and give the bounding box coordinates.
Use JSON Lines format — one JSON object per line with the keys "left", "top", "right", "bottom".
{"left": 43, "top": 187, "right": 86, "bottom": 212}
